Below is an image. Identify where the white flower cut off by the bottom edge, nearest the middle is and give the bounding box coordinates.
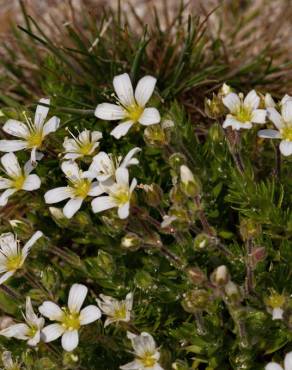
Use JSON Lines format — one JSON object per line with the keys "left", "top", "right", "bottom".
{"left": 120, "top": 332, "right": 163, "bottom": 370}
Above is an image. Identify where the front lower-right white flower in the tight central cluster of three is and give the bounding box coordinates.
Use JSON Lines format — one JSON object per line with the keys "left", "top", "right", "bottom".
{"left": 91, "top": 167, "right": 137, "bottom": 219}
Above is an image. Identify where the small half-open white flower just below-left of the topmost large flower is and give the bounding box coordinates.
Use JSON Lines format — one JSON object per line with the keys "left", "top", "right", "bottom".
{"left": 63, "top": 130, "right": 102, "bottom": 160}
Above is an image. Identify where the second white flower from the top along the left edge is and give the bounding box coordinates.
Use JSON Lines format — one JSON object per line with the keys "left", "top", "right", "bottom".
{"left": 0, "top": 153, "right": 41, "bottom": 207}
